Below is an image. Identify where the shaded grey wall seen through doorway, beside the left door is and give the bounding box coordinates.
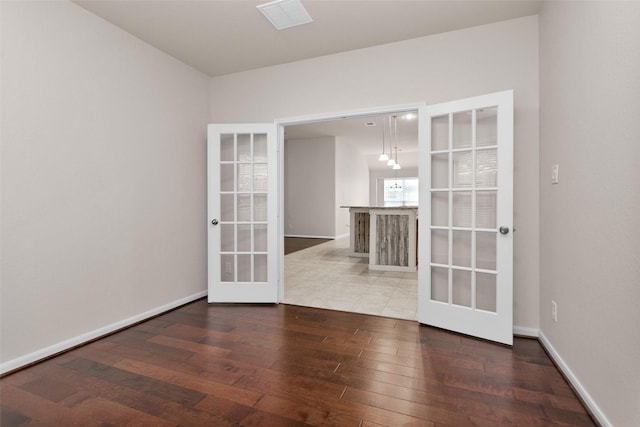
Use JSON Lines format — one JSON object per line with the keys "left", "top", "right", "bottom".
{"left": 284, "top": 137, "right": 336, "bottom": 238}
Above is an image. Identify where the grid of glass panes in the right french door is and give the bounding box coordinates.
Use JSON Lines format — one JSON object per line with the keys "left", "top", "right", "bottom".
{"left": 430, "top": 108, "right": 498, "bottom": 311}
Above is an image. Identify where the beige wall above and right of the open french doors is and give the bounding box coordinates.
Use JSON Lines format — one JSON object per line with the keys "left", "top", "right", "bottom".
{"left": 211, "top": 16, "right": 540, "bottom": 331}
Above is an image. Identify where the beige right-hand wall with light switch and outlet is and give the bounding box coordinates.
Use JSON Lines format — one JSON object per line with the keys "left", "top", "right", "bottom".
{"left": 540, "top": 2, "right": 640, "bottom": 427}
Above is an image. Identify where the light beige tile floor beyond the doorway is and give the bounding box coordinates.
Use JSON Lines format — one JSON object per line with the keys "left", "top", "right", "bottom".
{"left": 284, "top": 237, "right": 418, "bottom": 320}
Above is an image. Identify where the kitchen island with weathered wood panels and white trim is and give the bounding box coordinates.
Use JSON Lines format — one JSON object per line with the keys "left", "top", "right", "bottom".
{"left": 341, "top": 206, "right": 418, "bottom": 271}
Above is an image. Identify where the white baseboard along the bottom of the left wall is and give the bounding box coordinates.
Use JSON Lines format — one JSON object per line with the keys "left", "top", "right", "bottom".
{"left": 0, "top": 291, "right": 207, "bottom": 375}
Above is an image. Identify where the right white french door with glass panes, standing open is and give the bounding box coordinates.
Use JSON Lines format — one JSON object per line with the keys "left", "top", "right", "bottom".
{"left": 418, "top": 91, "right": 513, "bottom": 345}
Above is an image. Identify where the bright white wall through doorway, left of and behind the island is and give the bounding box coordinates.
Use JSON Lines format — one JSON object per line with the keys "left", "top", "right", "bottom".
{"left": 335, "top": 137, "right": 369, "bottom": 237}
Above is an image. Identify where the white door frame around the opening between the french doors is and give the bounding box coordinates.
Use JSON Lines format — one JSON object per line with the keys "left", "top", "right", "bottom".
{"left": 275, "top": 101, "right": 427, "bottom": 303}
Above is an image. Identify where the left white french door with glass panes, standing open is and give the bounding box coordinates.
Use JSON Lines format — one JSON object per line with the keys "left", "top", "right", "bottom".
{"left": 207, "top": 123, "right": 278, "bottom": 303}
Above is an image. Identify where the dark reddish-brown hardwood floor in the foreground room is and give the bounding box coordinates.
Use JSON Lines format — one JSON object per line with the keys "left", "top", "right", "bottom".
{"left": 0, "top": 300, "right": 594, "bottom": 427}
